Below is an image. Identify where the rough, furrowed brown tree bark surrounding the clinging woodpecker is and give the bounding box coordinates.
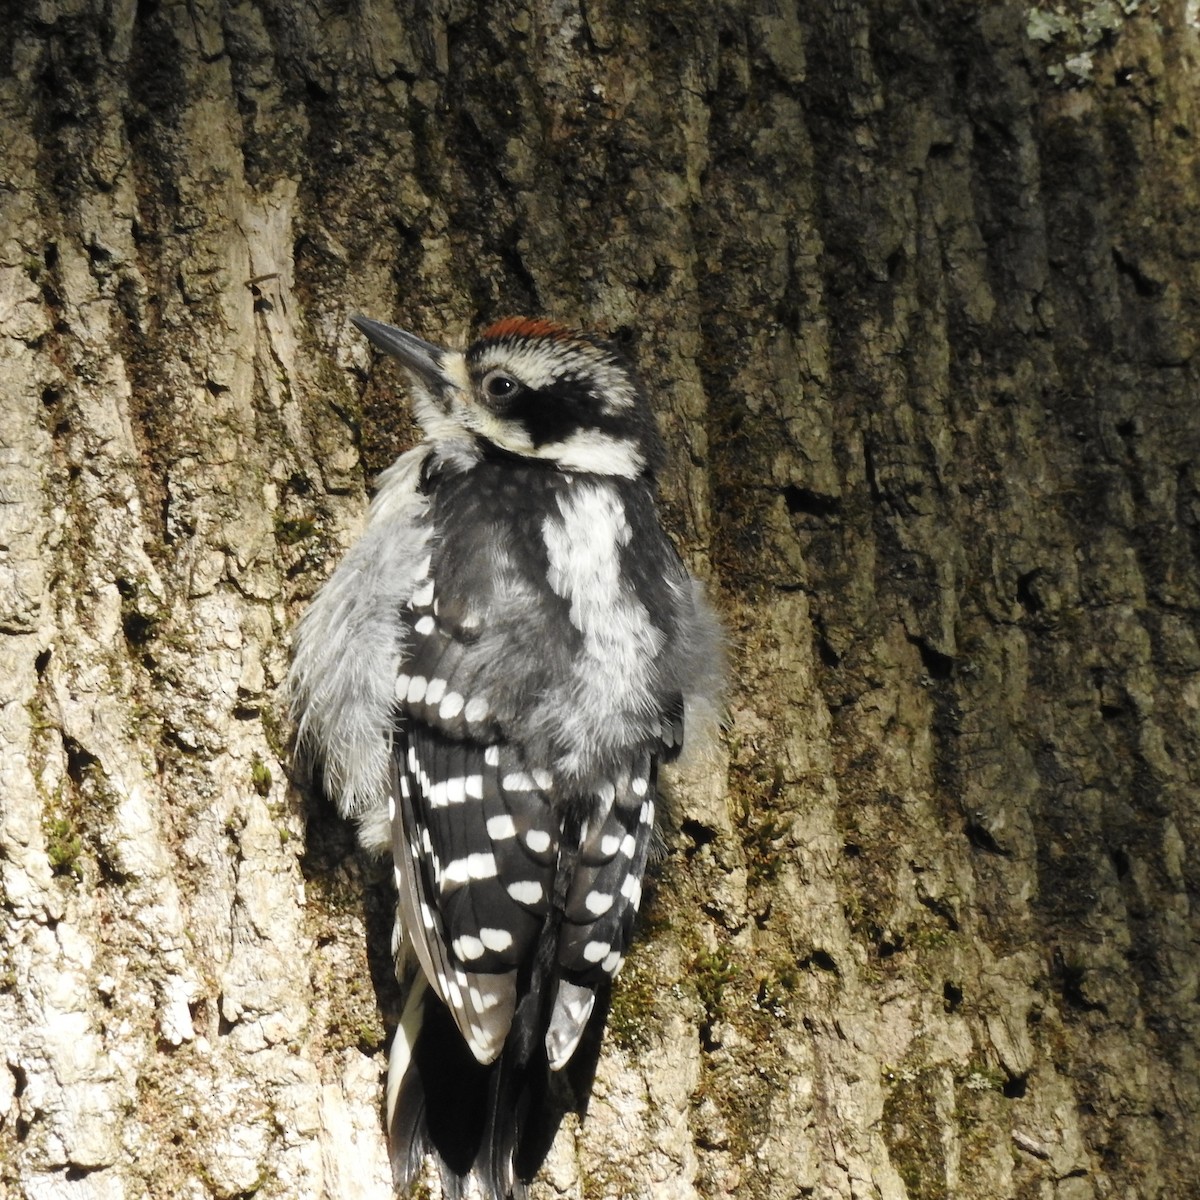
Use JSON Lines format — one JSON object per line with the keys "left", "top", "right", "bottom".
{"left": 0, "top": 0, "right": 1200, "bottom": 1200}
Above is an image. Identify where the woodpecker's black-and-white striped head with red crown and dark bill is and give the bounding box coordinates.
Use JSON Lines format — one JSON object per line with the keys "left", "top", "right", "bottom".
{"left": 350, "top": 317, "right": 661, "bottom": 479}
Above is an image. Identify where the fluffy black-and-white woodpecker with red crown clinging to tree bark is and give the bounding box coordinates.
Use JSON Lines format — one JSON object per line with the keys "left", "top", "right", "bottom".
{"left": 289, "top": 317, "right": 721, "bottom": 1200}
